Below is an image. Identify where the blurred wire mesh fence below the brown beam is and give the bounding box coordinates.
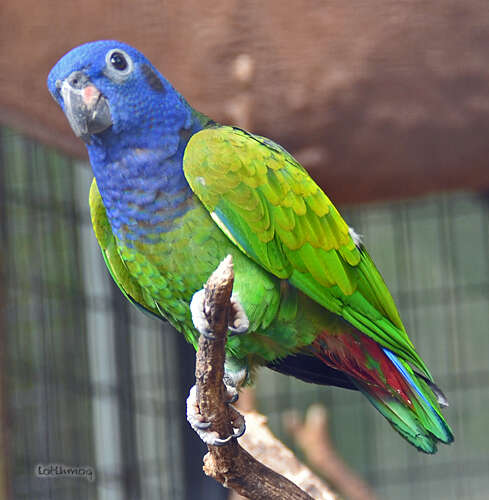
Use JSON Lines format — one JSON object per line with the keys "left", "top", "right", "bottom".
{"left": 0, "top": 129, "right": 489, "bottom": 500}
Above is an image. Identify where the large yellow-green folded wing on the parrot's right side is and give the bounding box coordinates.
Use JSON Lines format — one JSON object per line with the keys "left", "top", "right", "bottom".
{"left": 183, "top": 126, "right": 431, "bottom": 378}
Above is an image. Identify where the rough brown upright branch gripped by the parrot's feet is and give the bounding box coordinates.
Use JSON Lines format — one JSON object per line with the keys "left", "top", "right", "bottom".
{"left": 195, "top": 256, "right": 334, "bottom": 500}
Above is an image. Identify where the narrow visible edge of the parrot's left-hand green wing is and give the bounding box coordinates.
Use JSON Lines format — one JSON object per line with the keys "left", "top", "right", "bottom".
{"left": 89, "top": 179, "right": 162, "bottom": 318}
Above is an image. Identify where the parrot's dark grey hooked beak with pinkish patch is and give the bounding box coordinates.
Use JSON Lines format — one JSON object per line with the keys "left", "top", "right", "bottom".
{"left": 56, "top": 71, "right": 112, "bottom": 144}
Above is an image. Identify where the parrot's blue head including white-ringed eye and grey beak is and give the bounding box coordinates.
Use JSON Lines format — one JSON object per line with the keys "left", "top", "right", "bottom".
{"left": 47, "top": 40, "right": 191, "bottom": 158}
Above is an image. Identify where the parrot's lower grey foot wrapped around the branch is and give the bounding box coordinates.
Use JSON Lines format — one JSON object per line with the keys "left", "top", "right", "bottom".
{"left": 187, "top": 385, "right": 246, "bottom": 446}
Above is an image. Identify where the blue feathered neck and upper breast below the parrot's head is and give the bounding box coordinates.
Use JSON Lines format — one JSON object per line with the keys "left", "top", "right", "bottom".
{"left": 87, "top": 91, "right": 203, "bottom": 246}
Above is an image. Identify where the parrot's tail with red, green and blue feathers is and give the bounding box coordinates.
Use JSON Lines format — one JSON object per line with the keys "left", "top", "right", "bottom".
{"left": 312, "top": 330, "right": 453, "bottom": 453}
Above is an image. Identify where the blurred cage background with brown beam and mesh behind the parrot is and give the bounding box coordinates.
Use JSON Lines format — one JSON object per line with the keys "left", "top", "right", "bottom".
{"left": 0, "top": 0, "right": 489, "bottom": 500}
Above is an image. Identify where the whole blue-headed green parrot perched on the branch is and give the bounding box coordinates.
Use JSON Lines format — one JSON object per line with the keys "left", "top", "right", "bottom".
{"left": 47, "top": 40, "right": 454, "bottom": 454}
